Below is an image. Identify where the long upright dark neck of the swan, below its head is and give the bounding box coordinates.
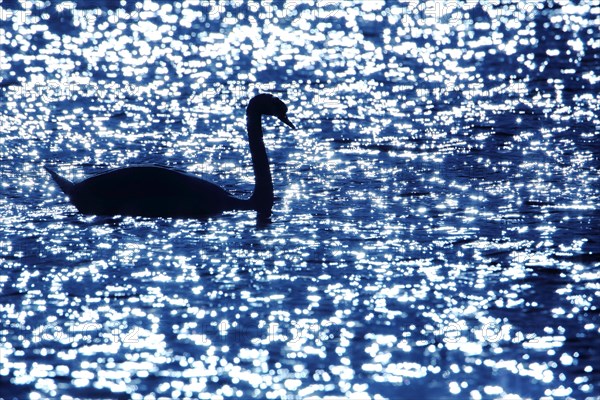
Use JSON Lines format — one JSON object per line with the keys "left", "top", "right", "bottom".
{"left": 246, "top": 110, "right": 273, "bottom": 213}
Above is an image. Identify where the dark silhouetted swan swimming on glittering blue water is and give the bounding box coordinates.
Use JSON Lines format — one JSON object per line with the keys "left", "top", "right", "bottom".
{"left": 45, "top": 94, "right": 295, "bottom": 218}
